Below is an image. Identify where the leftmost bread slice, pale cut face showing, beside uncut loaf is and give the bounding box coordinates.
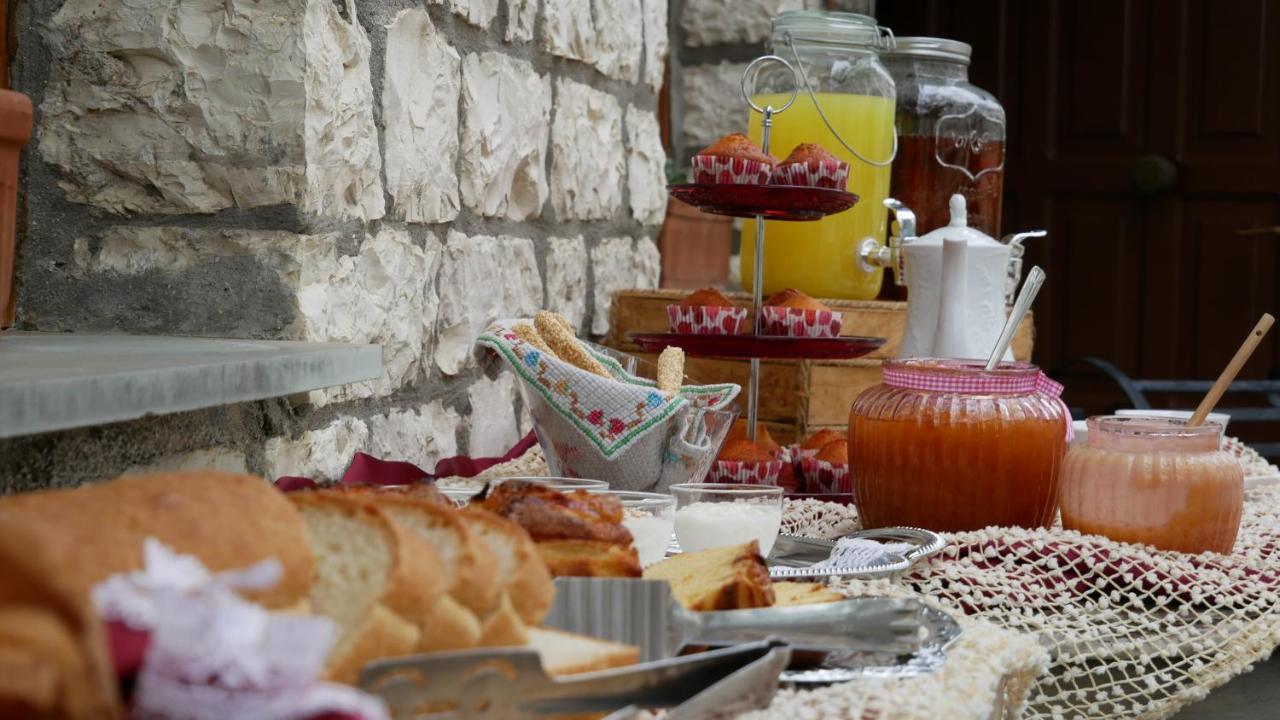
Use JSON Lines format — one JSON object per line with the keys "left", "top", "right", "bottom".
{"left": 289, "top": 491, "right": 444, "bottom": 683}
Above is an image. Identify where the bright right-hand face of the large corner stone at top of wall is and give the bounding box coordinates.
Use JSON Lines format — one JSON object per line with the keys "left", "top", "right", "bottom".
{"left": 302, "top": 0, "right": 384, "bottom": 220}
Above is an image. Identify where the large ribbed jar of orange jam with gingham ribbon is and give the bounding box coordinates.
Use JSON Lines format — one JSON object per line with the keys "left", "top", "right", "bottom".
{"left": 849, "top": 359, "right": 1071, "bottom": 532}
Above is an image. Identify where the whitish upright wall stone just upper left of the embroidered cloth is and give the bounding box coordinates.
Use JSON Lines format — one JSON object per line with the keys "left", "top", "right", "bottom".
{"left": 435, "top": 231, "right": 503, "bottom": 375}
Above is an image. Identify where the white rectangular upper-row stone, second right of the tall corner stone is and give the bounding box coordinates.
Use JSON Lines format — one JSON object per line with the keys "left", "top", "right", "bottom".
{"left": 462, "top": 53, "right": 552, "bottom": 220}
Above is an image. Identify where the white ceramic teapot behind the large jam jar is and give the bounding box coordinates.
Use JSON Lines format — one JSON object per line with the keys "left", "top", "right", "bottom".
{"left": 899, "top": 195, "right": 1043, "bottom": 360}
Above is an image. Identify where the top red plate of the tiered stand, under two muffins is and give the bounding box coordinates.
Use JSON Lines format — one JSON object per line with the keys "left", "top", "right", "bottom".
{"left": 667, "top": 183, "right": 858, "bottom": 220}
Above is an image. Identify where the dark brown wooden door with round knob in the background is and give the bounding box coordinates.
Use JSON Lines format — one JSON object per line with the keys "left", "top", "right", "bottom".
{"left": 877, "top": 0, "right": 1280, "bottom": 415}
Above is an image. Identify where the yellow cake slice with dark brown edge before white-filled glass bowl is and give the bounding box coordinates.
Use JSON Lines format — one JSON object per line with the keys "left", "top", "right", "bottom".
{"left": 644, "top": 541, "right": 773, "bottom": 610}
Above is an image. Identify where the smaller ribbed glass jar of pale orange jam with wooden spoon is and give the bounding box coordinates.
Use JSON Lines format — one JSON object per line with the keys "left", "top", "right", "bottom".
{"left": 1060, "top": 415, "right": 1244, "bottom": 553}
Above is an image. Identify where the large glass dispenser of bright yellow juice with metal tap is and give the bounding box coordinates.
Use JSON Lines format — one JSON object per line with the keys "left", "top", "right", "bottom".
{"left": 742, "top": 12, "right": 897, "bottom": 300}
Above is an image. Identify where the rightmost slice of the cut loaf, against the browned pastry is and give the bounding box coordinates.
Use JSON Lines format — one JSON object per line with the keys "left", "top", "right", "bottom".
{"left": 460, "top": 507, "right": 556, "bottom": 625}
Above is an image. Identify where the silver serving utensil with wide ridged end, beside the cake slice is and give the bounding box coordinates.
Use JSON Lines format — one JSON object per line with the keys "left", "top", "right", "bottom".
{"left": 545, "top": 578, "right": 924, "bottom": 660}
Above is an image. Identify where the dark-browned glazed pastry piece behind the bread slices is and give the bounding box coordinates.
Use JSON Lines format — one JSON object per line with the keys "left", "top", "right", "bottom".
{"left": 475, "top": 480, "right": 640, "bottom": 578}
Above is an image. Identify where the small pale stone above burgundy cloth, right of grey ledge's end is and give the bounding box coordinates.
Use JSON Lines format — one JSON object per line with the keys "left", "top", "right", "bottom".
{"left": 369, "top": 400, "right": 460, "bottom": 473}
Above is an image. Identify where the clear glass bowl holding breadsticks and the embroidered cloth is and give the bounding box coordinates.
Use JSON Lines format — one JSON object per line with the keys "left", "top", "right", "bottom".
{"left": 516, "top": 343, "right": 737, "bottom": 492}
